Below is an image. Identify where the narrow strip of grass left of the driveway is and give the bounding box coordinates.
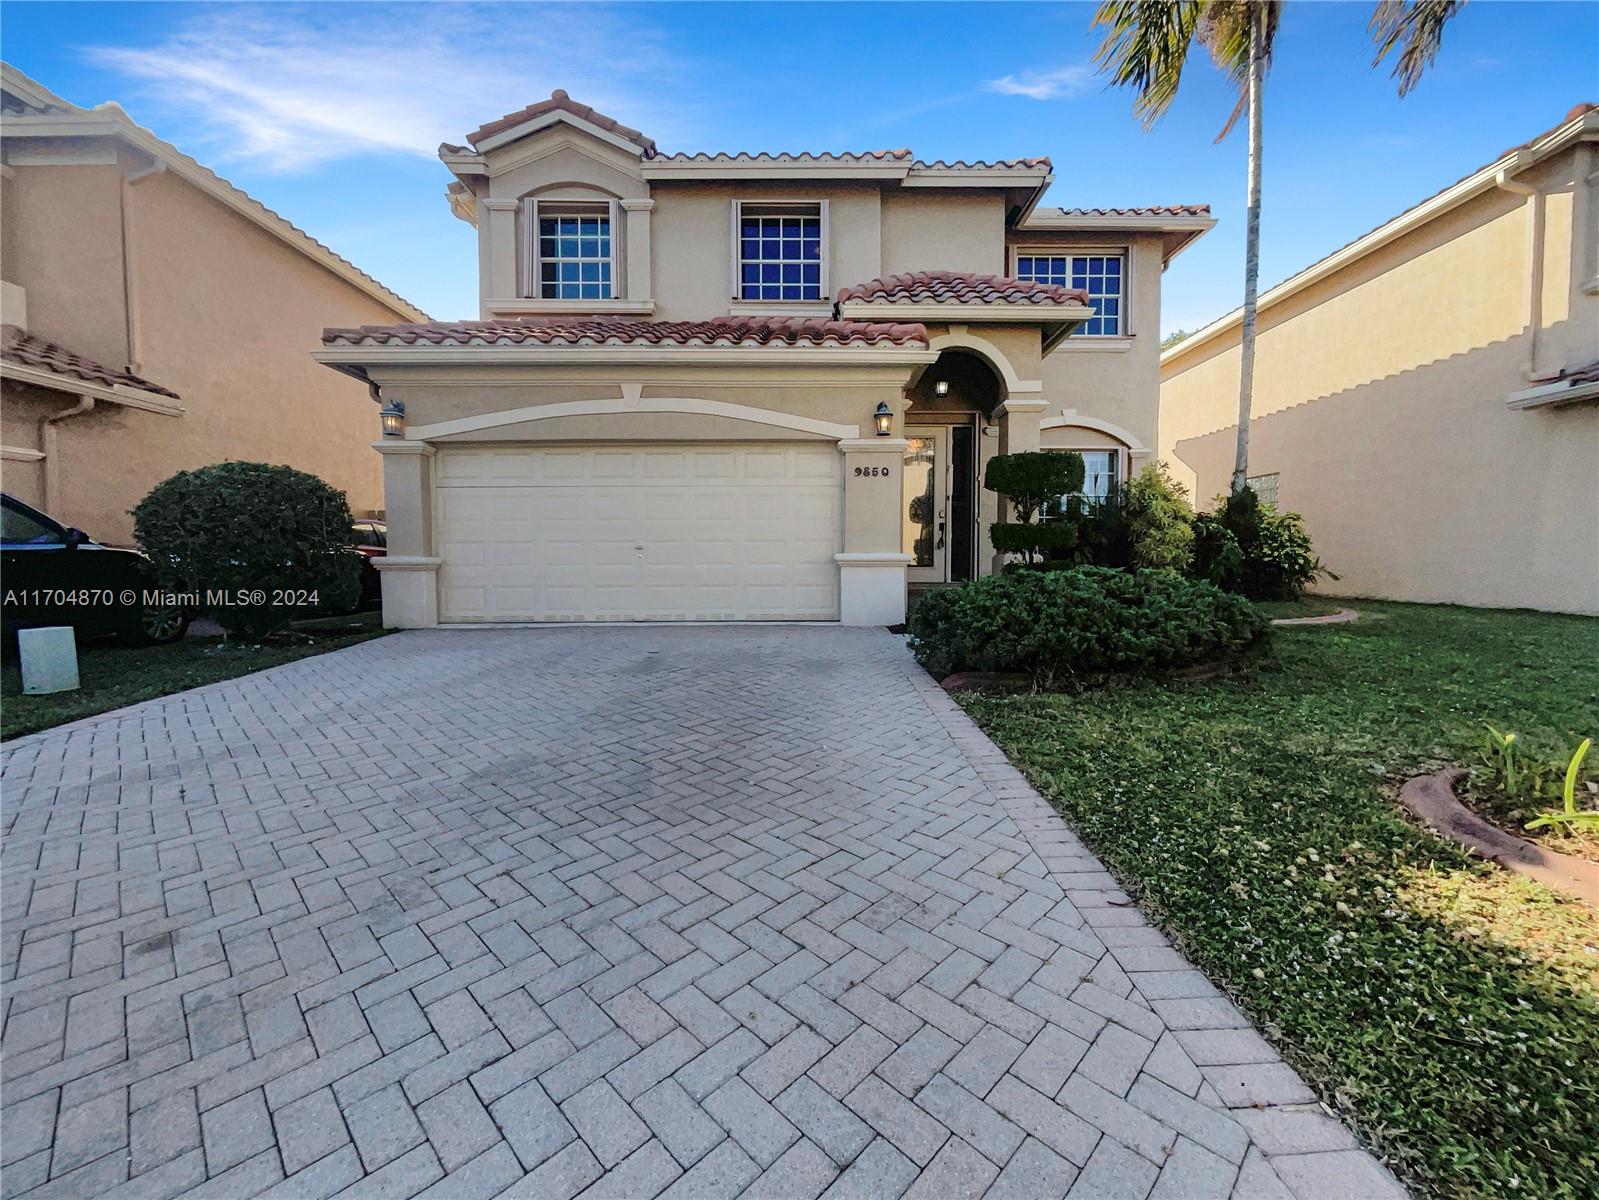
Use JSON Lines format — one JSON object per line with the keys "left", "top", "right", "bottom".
{"left": 0, "top": 630, "right": 382, "bottom": 739}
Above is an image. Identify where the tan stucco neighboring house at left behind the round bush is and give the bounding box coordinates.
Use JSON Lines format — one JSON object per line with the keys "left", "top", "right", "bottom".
{"left": 0, "top": 66, "right": 425, "bottom": 544}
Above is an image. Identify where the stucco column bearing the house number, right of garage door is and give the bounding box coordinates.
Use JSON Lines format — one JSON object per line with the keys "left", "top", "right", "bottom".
{"left": 833, "top": 437, "right": 910, "bottom": 626}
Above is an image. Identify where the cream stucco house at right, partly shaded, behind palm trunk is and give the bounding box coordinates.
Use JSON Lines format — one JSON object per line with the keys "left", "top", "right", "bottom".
{"left": 1159, "top": 106, "right": 1599, "bottom": 613}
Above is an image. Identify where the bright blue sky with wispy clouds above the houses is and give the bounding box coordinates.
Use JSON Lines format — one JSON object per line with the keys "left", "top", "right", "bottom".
{"left": 0, "top": 0, "right": 1599, "bottom": 331}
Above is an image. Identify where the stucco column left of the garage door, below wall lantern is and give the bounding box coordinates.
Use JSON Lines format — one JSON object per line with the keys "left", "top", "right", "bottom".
{"left": 373, "top": 440, "right": 441, "bottom": 629}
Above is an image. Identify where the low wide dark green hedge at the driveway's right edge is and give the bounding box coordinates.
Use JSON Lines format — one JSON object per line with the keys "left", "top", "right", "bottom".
{"left": 908, "top": 566, "right": 1270, "bottom": 688}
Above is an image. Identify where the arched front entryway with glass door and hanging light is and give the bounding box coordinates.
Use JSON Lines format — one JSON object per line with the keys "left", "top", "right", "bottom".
{"left": 900, "top": 349, "right": 1006, "bottom": 587}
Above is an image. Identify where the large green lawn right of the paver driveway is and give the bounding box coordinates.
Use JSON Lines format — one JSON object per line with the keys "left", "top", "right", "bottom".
{"left": 961, "top": 602, "right": 1599, "bottom": 1200}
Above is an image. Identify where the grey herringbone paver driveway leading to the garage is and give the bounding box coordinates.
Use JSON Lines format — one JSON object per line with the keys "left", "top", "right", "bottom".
{"left": 3, "top": 627, "right": 1396, "bottom": 1200}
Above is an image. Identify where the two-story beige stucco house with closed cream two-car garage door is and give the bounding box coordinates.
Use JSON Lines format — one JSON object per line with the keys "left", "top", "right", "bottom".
{"left": 317, "top": 91, "right": 1212, "bottom": 626}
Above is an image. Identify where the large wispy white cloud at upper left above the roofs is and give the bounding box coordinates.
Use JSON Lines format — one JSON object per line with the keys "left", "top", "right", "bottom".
{"left": 86, "top": 5, "right": 700, "bottom": 171}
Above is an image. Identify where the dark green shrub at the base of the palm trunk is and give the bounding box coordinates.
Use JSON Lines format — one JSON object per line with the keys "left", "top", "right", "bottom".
{"left": 1193, "top": 488, "right": 1317, "bottom": 600}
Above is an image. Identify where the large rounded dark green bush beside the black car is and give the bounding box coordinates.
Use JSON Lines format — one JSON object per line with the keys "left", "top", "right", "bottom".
{"left": 133, "top": 462, "right": 361, "bottom": 635}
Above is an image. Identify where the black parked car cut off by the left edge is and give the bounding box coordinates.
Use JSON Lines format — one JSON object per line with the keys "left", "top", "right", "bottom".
{"left": 0, "top": 494, "right": 189, "bottom": 646}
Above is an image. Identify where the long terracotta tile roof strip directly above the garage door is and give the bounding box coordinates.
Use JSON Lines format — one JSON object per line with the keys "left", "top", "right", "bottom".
{"left": 321, "top": 317, "right": 927, "bottom": 347}
